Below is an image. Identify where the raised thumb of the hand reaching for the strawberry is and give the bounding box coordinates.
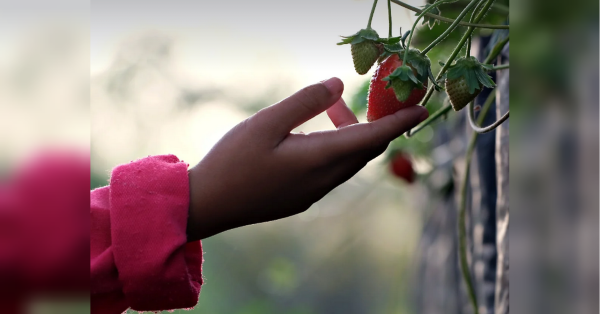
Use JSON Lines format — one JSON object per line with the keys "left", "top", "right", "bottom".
{"left": 253, "top": 77, "right": 344, "bottom": 137}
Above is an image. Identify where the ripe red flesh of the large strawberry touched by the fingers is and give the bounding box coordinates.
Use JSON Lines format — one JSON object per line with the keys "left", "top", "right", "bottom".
{"left": 367, "top": 53, "right": 427, "bottom": 122}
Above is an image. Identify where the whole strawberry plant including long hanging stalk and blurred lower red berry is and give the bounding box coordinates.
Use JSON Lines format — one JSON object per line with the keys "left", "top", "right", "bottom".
{"left": 338, "top": 0, "right": 509, "bottom": 313}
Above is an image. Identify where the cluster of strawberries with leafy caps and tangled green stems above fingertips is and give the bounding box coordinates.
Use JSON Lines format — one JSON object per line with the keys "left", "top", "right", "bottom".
{"left": 338, "top": 0, "right": 508, "bottom": 132}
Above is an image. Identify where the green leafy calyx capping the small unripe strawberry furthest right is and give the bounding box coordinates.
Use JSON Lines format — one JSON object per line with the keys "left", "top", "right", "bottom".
{"left": 446, "top": 56, "right": 496, "bottom": 94}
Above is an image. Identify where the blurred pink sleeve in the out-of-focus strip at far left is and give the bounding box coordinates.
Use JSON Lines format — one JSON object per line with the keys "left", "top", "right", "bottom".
{"left": 0, "top": 150, "right": 90, "bottom": 314}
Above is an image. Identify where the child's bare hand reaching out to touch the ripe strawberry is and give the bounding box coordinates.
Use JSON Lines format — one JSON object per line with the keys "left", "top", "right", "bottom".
{"left": 187, "top": 78, "right": 428, "bottom": 241}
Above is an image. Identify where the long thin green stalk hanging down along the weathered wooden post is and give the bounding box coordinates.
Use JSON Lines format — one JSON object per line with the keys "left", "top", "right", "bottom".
{"left": 458, "top": 91, "right": 496, "bottom": 314}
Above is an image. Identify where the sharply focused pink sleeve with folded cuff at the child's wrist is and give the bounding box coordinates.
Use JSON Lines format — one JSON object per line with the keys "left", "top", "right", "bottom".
{"left": 90, "top": 155, "right": 203, "bottom": 313}
